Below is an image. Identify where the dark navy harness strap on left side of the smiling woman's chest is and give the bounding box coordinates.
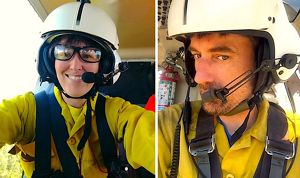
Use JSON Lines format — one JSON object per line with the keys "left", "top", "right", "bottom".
{"left": 33, "top": 91, "right": 82, "bottom": 178}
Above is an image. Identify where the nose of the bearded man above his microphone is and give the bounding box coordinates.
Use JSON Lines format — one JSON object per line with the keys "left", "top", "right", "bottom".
{"left": 194, "top": 58, "right": 214, "bottom": 84}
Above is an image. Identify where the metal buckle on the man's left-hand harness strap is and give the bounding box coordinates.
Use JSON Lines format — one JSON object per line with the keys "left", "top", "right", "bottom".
{"left": 189, "top": 134, "right": 215, "bottom": 156}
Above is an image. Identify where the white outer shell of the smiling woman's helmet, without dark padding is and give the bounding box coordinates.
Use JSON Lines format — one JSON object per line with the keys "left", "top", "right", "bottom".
{"left": 41, "top": 2, "right": 119, "bottom": 49}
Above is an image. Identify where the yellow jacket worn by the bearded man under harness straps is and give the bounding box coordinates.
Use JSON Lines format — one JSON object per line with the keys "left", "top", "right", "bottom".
{"left": 158, "top": 101, "right": 300, "bottom": 178}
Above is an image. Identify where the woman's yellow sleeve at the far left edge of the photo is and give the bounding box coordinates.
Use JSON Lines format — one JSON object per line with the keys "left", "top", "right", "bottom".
{"left": 0, "top": 92, "right": 36, "bottom": 145}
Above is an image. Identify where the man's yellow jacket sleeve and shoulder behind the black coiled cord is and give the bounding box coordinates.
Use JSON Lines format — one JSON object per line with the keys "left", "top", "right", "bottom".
{"left": 158, "top": 101, "right": 201, "bottom": 178}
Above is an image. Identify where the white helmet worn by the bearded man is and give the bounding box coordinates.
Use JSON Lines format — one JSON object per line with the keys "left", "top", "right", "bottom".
{"left": 168, "top": 0, "right": 300, "bottom": 94}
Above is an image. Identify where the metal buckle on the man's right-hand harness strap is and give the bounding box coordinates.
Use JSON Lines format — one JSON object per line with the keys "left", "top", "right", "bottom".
{"left": 265, "top": 137, "right": 295, "bottom": 160}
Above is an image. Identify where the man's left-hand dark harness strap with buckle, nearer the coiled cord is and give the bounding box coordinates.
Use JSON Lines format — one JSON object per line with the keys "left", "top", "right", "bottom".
{"left": 189, "top": 109, "right": 222, "bottom": 178}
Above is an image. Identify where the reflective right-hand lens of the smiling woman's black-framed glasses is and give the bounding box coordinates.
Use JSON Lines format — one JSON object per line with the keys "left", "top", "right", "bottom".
{"left": 80, "top": 47, "right": 102, "bottom": 62}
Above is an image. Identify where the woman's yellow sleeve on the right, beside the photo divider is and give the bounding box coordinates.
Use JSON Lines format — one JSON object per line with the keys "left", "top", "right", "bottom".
{"left": 105, "top": 98, "right": 155, "bottom": 174}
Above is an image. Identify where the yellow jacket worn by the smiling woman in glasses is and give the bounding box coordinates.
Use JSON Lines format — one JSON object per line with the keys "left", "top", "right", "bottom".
{"left": 0, "top": 88, "right": 155, "bottom": 178}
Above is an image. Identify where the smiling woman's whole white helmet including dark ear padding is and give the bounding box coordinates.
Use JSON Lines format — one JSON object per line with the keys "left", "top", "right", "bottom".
{"left": 38, "top": 2, "right": 121, "bottom": 96}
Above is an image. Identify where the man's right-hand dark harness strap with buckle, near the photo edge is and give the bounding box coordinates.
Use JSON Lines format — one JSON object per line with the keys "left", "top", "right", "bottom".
{"left": 254, "top": 102, "right": 295, "bottom": 178}
